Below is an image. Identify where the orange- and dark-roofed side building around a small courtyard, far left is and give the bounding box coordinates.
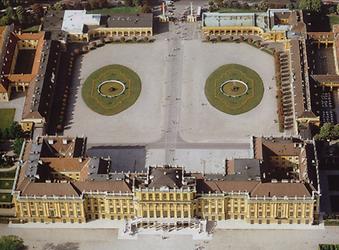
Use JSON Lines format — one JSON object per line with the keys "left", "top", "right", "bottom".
{"left": 0, "top": 25, "right": 63, "bottom": 131}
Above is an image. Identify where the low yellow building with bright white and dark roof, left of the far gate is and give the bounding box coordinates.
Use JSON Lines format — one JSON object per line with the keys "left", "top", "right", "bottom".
{"left": 56, "top": 10, "right": 153, "bottom": 42}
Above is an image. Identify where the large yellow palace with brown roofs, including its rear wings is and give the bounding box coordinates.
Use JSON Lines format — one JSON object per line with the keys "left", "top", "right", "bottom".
{"left": 13, "top": 136, "right": 319, "bottom": 227}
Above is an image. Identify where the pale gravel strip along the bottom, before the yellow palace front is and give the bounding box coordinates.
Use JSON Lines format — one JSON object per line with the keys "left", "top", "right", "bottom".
{"left": 0, "top": 225, "right": 339, "bottom": 250}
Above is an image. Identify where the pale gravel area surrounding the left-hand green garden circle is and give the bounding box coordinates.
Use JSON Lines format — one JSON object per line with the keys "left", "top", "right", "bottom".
{"left": 65, "top": 41, "right": 166, "bottom": 145}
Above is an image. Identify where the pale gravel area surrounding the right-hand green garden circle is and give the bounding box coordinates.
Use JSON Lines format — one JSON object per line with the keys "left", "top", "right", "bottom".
{"left": 180, "top": 40, "right": 282, "bottom": 143}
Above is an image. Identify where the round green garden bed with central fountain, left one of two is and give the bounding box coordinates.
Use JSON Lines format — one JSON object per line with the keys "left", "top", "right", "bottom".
{"left": 82, "top": 64, "right": 141, "bottom": 116}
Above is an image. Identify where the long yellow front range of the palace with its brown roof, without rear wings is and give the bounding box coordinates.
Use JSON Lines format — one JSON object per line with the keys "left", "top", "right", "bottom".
{"left": 14, "top": 167, "right": 318, "bottom": 224}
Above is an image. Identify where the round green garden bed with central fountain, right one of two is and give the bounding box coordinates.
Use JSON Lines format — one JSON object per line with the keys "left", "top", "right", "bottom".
{"left": 205, "top": 64, "right": 264, "bottom": 115}
